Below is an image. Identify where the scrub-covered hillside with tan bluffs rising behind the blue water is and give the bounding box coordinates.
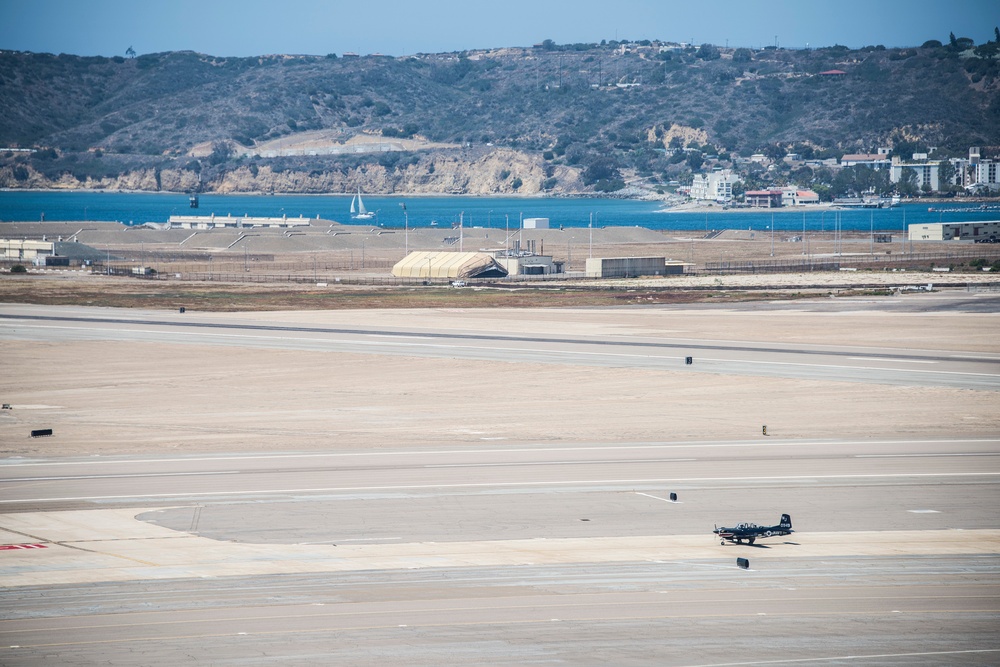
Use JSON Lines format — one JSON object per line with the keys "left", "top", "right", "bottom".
{"left": 0, "top": 39, "right": 1000, "bottom": 194}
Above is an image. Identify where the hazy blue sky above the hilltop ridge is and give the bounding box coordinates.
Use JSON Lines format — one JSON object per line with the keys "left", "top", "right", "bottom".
{"left": 0, "top": 0, "right": 1000, "bottom": 56}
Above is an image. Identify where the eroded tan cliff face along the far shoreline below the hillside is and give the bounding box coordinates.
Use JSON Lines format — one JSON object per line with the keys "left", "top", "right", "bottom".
{"left": 0, "top": 149, "right": 583, "bottom": 195}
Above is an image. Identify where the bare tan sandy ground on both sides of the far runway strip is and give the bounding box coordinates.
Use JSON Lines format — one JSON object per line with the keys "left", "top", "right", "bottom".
{"left": 0, "top": 297, "right": 1000, "bottom": 456}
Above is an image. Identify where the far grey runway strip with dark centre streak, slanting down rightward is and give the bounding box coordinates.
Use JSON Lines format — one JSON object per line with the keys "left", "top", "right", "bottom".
{"left": 0, "top": 308, "right": 1000, "bottom": 391}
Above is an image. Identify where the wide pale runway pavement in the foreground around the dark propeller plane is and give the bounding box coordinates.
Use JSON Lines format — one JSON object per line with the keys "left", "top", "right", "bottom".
{"left": 0, "top": 439, "right": 1000, "bottom": 665}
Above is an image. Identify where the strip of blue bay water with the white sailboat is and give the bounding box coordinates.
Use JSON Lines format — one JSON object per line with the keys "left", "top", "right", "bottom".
{"left": 0, "top": 191, "right": 1000, "bottom": 232}
